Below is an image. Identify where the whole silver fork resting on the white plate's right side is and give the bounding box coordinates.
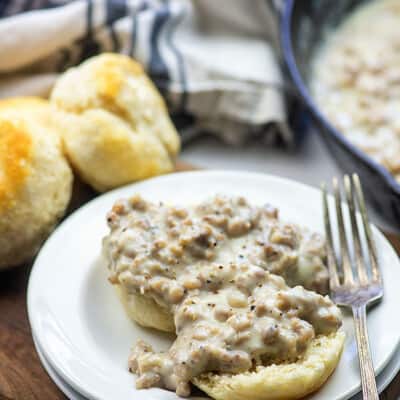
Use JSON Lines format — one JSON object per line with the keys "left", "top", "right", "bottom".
{"left": 322, "top": 174, "right": 383, "bottom": 400}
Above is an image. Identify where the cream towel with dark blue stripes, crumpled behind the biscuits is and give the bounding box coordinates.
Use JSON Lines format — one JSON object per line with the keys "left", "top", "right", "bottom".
{"left": 0, "top": 0, "right": 291, "bottom": 143}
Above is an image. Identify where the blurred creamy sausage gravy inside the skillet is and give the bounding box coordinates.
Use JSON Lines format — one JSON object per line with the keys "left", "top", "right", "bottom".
{"left": 311, "top": 0, "right": 400, "bottom": 181}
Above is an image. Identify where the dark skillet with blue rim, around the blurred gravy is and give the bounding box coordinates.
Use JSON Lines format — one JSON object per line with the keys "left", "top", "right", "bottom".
{"left": 280, "top": 0, "right": 400, "bottom": 229}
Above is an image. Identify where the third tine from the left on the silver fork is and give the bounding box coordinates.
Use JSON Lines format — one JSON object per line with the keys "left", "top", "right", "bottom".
{"left": 344, "top": 175, "right": 368, "bottom": 285}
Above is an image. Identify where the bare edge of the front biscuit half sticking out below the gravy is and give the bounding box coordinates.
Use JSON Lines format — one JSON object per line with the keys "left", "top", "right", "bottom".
{"left": 193, "top": 331, "right": 345, "bottom": 400}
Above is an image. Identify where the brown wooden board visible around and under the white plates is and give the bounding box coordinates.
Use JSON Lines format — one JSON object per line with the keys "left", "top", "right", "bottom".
{"left": 0, "top": 163, "right": 400, "bottom": 400}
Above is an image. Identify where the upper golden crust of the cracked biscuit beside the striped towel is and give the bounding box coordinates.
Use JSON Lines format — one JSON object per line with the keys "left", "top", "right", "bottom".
{"left": 51, "top": 53, "right": 180, "bottom": 157}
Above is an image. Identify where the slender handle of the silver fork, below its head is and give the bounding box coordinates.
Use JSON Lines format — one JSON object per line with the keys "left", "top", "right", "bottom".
{"left": 353, "top": 304, "right": 379, "bottom": 400}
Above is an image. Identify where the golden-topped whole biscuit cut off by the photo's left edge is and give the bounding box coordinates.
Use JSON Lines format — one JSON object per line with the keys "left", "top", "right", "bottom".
{"left": 0, "top": 97, "right": 72, "bottom": 269}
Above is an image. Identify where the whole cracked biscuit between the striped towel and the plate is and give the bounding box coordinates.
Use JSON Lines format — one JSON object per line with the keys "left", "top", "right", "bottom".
{"left": 51, "top": 54, "right": 180, "bottom": 191}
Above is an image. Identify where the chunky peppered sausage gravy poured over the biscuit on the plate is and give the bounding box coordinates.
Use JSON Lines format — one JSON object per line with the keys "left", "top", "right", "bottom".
{"left": 104, "top": 196, "right": 341, "bottom": 396}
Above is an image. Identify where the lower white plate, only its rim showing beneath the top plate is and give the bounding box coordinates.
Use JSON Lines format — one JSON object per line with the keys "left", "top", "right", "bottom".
{"left": 33, "top": 337, "right": 400, "bottom": 400}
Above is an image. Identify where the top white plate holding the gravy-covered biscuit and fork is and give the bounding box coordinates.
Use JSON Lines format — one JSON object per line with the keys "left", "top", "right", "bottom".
{"left": 28, "top": 172, "right": 400, "bottom": 400}
